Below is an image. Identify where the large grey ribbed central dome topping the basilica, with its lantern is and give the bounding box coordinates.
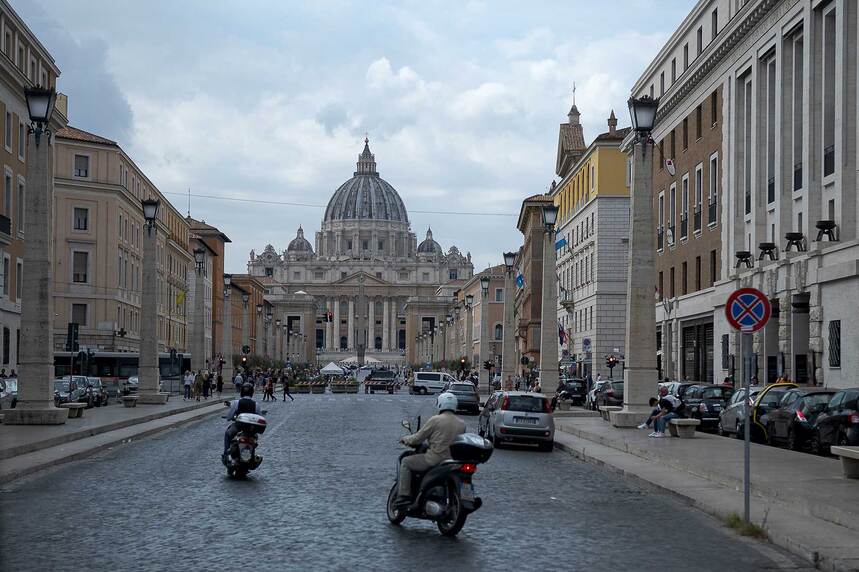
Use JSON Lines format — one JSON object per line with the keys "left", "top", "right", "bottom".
{"left": 325, "top": 139, "right": 409, "bottom": 225}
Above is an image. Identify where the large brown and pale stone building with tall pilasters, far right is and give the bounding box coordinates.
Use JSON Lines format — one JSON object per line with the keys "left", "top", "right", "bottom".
{"left": 633, "top": 0, "right": 859, "bottom": 387}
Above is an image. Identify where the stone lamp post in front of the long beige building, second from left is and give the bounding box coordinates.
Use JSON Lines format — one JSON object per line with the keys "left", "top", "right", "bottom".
{"left": 137, "top": 199, "right": 169, "bottom": 404}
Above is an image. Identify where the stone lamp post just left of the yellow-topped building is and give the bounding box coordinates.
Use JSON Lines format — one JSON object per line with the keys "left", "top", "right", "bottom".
{"left": 540, "top": 204, "right": 558, "bottom": 391}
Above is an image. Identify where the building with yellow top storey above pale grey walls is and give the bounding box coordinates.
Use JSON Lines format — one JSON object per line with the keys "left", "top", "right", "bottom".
{"left": 552, "top": 112, "right": 629, "bottom": 377}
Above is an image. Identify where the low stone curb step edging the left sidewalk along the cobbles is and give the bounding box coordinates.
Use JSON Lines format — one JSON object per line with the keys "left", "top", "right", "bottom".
{"left": 0, "top": 404, "right": 224, "bottom": 485}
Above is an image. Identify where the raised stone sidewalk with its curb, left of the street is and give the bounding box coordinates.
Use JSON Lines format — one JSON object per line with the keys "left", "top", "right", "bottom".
{"left": 0, "top": 396, "right": 225, "bottom": 483}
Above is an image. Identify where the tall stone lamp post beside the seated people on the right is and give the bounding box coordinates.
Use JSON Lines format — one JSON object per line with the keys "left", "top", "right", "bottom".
{"left": 611, "top": 96, "right": 659, "bottom": 427}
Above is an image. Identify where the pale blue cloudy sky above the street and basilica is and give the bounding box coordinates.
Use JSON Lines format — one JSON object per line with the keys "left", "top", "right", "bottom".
{"left": 16, "top": 0, "right": 694, "bottom": 272}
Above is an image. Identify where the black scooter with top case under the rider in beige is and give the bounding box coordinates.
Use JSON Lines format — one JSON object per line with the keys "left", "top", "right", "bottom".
{"left": 387, "top": 417, "right": 492, "bottom": 536}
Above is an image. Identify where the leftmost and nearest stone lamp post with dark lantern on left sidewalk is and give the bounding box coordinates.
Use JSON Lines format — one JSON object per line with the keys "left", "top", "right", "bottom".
{"left": 3, "top": 86, "right": 69, "bottom": 425}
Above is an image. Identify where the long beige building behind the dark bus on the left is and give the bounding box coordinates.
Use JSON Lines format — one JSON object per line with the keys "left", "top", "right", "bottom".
{"left": 54, "top": 123, "right": 194, "bottom": 352}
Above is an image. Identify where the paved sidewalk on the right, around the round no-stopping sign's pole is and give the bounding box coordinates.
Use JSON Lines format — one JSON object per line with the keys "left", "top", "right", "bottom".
{"left": 555, "top": 416, "right": 859, "bottom": 571}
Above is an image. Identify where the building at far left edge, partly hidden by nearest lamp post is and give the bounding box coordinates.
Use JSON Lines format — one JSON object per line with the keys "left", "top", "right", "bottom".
{"left": 0, "top": 0, "right": 65, "bottom": 372}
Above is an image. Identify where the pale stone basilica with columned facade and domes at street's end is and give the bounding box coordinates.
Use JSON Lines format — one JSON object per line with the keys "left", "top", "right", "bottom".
{"left": 248, "top": 139, "right": 474, "bottom": 363}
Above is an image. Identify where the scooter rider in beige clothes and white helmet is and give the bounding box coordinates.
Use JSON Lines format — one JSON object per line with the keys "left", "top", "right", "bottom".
{"left": 396, "top": 393, "right": 465, "bottom": 506}
